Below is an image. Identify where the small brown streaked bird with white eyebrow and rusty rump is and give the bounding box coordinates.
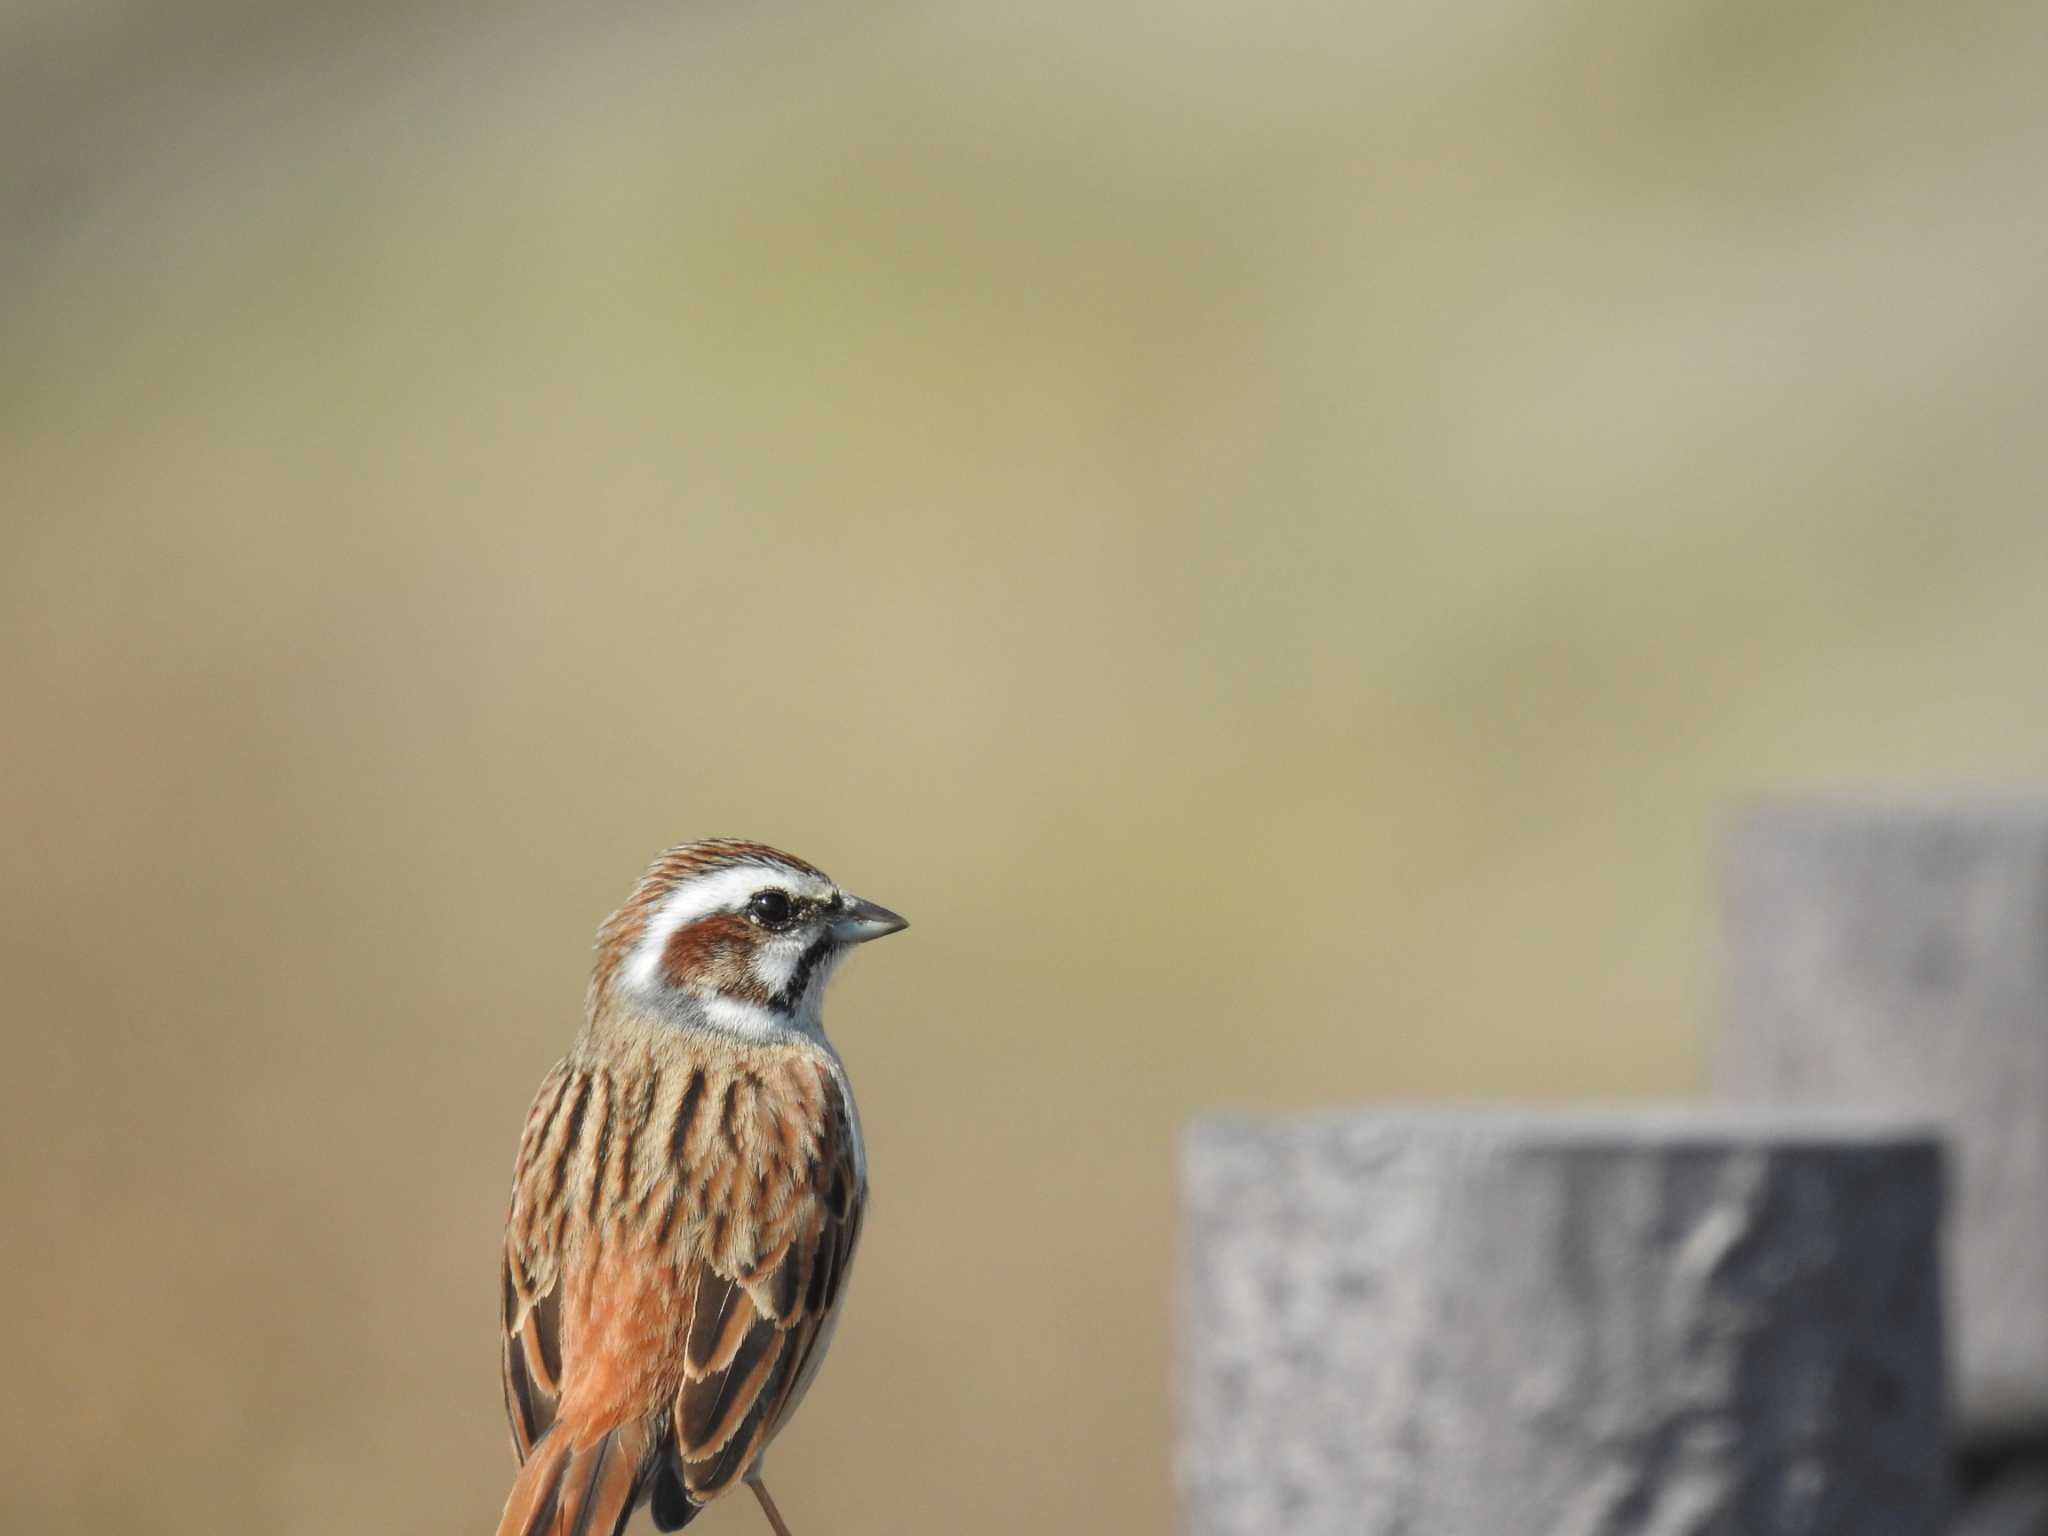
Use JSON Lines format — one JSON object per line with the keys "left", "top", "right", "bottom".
{"left": 498, "top": 838, "right": 909, "bottom": 1536}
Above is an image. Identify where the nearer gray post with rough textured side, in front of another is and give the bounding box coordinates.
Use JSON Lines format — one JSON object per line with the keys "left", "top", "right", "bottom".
{"left": 1176, "top": 1110, "right": 1946, "bottom": 1536}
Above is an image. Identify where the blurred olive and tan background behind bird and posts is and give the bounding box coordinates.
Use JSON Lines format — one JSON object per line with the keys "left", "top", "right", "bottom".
{"left": 0, "top": 0, "right": 2048, "bottom": 1536}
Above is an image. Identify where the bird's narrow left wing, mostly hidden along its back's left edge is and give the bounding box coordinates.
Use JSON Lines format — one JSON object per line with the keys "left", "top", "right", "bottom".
{"left": 500, "top": 1063, "right": 590, "bottom": 1464}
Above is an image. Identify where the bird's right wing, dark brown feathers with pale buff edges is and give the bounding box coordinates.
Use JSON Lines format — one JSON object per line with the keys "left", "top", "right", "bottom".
{"left": 674, "top": 1073, "right": 866, "bottom": 1503}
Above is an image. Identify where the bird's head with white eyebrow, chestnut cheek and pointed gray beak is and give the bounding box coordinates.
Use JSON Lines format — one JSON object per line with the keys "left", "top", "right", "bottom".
{"left": 590, "top": 838, "right": 907, "bottom": 1038}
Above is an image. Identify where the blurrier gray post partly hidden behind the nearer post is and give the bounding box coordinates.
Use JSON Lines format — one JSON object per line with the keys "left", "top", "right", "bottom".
{"left": 1716, "top": 803, "right": 2048, "bottom": 1440}
